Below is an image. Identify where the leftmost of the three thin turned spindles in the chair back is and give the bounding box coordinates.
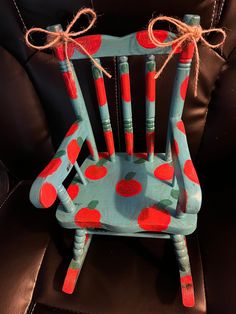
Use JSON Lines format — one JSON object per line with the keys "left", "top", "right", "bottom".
{"left": 92, "top": 58, "right": 115, "bottom": 161}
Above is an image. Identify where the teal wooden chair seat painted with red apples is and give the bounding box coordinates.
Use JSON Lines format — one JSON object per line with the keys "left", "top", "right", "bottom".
{"left": 56, "top": 153, "right": 197, "bottom": 234}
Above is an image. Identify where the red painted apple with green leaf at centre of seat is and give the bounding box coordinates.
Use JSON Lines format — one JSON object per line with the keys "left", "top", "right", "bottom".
{"left": 116, "top": 172, "right": 142, "bottom": 197}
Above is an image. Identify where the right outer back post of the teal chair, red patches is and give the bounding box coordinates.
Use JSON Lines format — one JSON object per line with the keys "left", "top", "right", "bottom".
{"left": 165, "top": 14, "right": 200, "bottom": 161}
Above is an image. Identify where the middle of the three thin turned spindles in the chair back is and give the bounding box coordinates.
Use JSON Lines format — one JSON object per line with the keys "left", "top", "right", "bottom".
{"left": 119, "top": 56, "right": 134, "bottom": 156}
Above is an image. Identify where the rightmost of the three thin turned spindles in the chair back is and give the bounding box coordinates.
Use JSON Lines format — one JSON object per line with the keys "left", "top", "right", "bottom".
{"left": 145, "top": 55, "right": 156, "bottom": 161}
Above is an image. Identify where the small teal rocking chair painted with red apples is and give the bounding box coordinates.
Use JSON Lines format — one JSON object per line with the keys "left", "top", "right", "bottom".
{"left": 30, "top": 15, "right": 201, "bottom": 307}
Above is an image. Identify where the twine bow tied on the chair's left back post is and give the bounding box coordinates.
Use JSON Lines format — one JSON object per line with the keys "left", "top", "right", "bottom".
{"left": 25, "top": 8, "right": 111, "bottom": 78}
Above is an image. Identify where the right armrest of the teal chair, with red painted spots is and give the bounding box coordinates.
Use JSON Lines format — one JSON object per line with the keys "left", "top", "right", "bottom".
{"left": 171, "top": 119, "right": 202, "bottom": 215}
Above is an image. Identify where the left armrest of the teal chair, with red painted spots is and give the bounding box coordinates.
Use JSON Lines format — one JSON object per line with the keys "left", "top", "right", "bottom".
{"left": 30, "top": 121, "right": 86, "bottom": 208}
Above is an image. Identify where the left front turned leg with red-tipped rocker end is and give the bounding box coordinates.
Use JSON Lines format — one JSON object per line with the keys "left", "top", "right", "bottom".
{"left": 62, "top": 229, "right": 92, "bottom": 294}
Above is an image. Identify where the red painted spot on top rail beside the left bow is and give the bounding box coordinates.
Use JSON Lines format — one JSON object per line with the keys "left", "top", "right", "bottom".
{"left": 74, "top": 35, "right": 102, "bottom": 55}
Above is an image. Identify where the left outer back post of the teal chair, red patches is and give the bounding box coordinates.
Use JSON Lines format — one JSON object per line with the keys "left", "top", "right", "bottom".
{"left": 47, "top": 24, "right": 99, "bottom": 160}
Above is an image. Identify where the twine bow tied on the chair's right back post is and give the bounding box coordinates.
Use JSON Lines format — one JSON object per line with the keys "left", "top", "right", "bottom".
{"left": 148, "top": 16, "right": 226, "bottom": 97}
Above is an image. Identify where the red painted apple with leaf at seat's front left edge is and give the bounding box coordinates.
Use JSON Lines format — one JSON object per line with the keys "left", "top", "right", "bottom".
{"left": 75, "top": 200, "right": 101, "bottom": 228}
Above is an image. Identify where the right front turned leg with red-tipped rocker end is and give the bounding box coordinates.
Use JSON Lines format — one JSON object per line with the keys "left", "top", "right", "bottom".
{"left": 171, "top": 235, "right": 195, "bottom": 307}
